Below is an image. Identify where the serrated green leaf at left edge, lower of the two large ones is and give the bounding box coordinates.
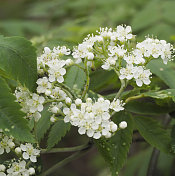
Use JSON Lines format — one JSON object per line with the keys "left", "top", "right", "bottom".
{"left": 0, "top": 77, "right": 34, "bottom": 142}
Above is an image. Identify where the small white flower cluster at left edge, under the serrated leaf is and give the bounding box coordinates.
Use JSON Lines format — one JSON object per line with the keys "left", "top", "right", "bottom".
{"left": 0, "top": 129, "right": 15, "bottom": 155}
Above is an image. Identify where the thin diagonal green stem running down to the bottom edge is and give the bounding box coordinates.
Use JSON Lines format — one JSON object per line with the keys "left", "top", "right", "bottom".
{"left": 40, "top": 143, "right": 92, "bottom": 176}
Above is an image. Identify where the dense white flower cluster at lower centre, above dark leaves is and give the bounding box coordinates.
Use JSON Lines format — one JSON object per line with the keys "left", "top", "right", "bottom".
{"left": 63, "top": 98, "right": 124, "bottom": 139}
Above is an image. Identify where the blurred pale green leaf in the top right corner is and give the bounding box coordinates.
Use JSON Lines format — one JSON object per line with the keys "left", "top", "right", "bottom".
{"left": 131, "top": 0, "right": 175, "bottom": 40}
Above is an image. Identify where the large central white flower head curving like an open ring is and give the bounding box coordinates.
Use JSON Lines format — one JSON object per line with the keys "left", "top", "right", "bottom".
{"left": 15, "top": 25, "right": 173, "bottom": 139}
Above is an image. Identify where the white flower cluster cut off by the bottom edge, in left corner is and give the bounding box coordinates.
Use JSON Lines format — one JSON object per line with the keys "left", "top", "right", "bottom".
{"left": 0, "top": 160, "right": 35, "bottom": 176}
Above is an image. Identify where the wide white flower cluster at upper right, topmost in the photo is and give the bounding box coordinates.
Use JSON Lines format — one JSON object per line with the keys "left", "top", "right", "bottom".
{"left": 72, "top": 25, "right": 173, "bottom": 87}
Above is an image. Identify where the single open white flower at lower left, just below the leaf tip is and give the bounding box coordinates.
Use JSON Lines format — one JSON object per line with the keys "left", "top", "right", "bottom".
{"left": 20, "top": 143, "right": 40, "bottom": 162}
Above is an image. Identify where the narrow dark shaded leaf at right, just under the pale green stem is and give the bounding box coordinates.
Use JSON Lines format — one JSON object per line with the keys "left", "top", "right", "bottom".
{"left": 125, "top": 101, "right": 175, "bottom": 115}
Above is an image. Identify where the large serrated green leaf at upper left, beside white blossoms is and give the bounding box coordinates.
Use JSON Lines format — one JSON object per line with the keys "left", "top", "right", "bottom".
{"left": 0, "top": 37, "right": 37, "bottom": 91}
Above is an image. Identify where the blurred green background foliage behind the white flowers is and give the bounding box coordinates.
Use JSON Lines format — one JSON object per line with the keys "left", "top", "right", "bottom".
{"left": 0, "top": 0, "right": 175, "bottom": 176}
